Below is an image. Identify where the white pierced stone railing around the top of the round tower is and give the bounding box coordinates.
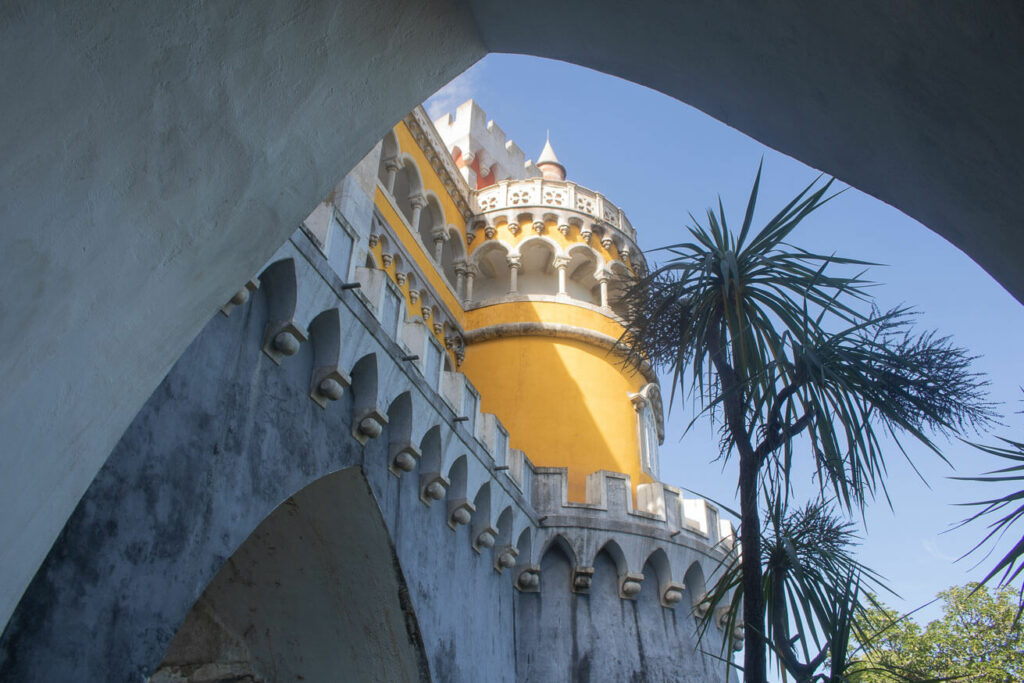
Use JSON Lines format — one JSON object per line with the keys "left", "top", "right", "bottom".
{"left": 473, "top": 178, "right": 636, "bottom": 244}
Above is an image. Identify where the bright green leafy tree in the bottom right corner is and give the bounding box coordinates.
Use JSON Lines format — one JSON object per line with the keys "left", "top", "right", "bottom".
{"left": 850, "top": 584, "right": 1024, "bottom": 683}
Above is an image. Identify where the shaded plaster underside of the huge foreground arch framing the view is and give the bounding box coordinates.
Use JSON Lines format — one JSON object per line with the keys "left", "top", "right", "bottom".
{"left": 0, "top": 0, "right": 1024, "bottom": 643}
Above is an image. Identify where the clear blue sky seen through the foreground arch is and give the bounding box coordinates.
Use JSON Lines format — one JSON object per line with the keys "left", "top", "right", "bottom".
{"left": 426, "top": 54, "right": 1024, "bottom": 621}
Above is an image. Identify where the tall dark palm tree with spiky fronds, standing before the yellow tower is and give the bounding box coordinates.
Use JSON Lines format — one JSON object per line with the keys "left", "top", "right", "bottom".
{"left": 622, "top": 167, "right": 992, "bottom": 681}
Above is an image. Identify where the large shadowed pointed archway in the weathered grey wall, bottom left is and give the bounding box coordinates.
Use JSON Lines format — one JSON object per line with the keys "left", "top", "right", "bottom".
{"left": 154, "top": 468, "right": 428, "bottom": 681}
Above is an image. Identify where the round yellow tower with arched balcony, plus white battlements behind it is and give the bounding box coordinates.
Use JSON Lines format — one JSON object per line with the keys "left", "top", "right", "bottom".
{"left": 435, "top": 101, "right": 664, "bottom": 501}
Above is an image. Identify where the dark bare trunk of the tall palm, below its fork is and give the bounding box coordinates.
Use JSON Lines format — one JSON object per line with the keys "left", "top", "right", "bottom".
{"left": 741, "top": 454, "right": 768, "bottom": 683}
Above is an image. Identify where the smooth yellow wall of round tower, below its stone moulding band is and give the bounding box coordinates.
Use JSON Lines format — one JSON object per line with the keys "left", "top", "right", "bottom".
{"left": 461, "top": 337, "right": 651, "bottom": 502}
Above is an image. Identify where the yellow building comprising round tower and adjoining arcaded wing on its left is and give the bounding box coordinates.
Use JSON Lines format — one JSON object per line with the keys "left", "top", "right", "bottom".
{"left": 368, "top": 100, "right": 664, "bottom": 502}
